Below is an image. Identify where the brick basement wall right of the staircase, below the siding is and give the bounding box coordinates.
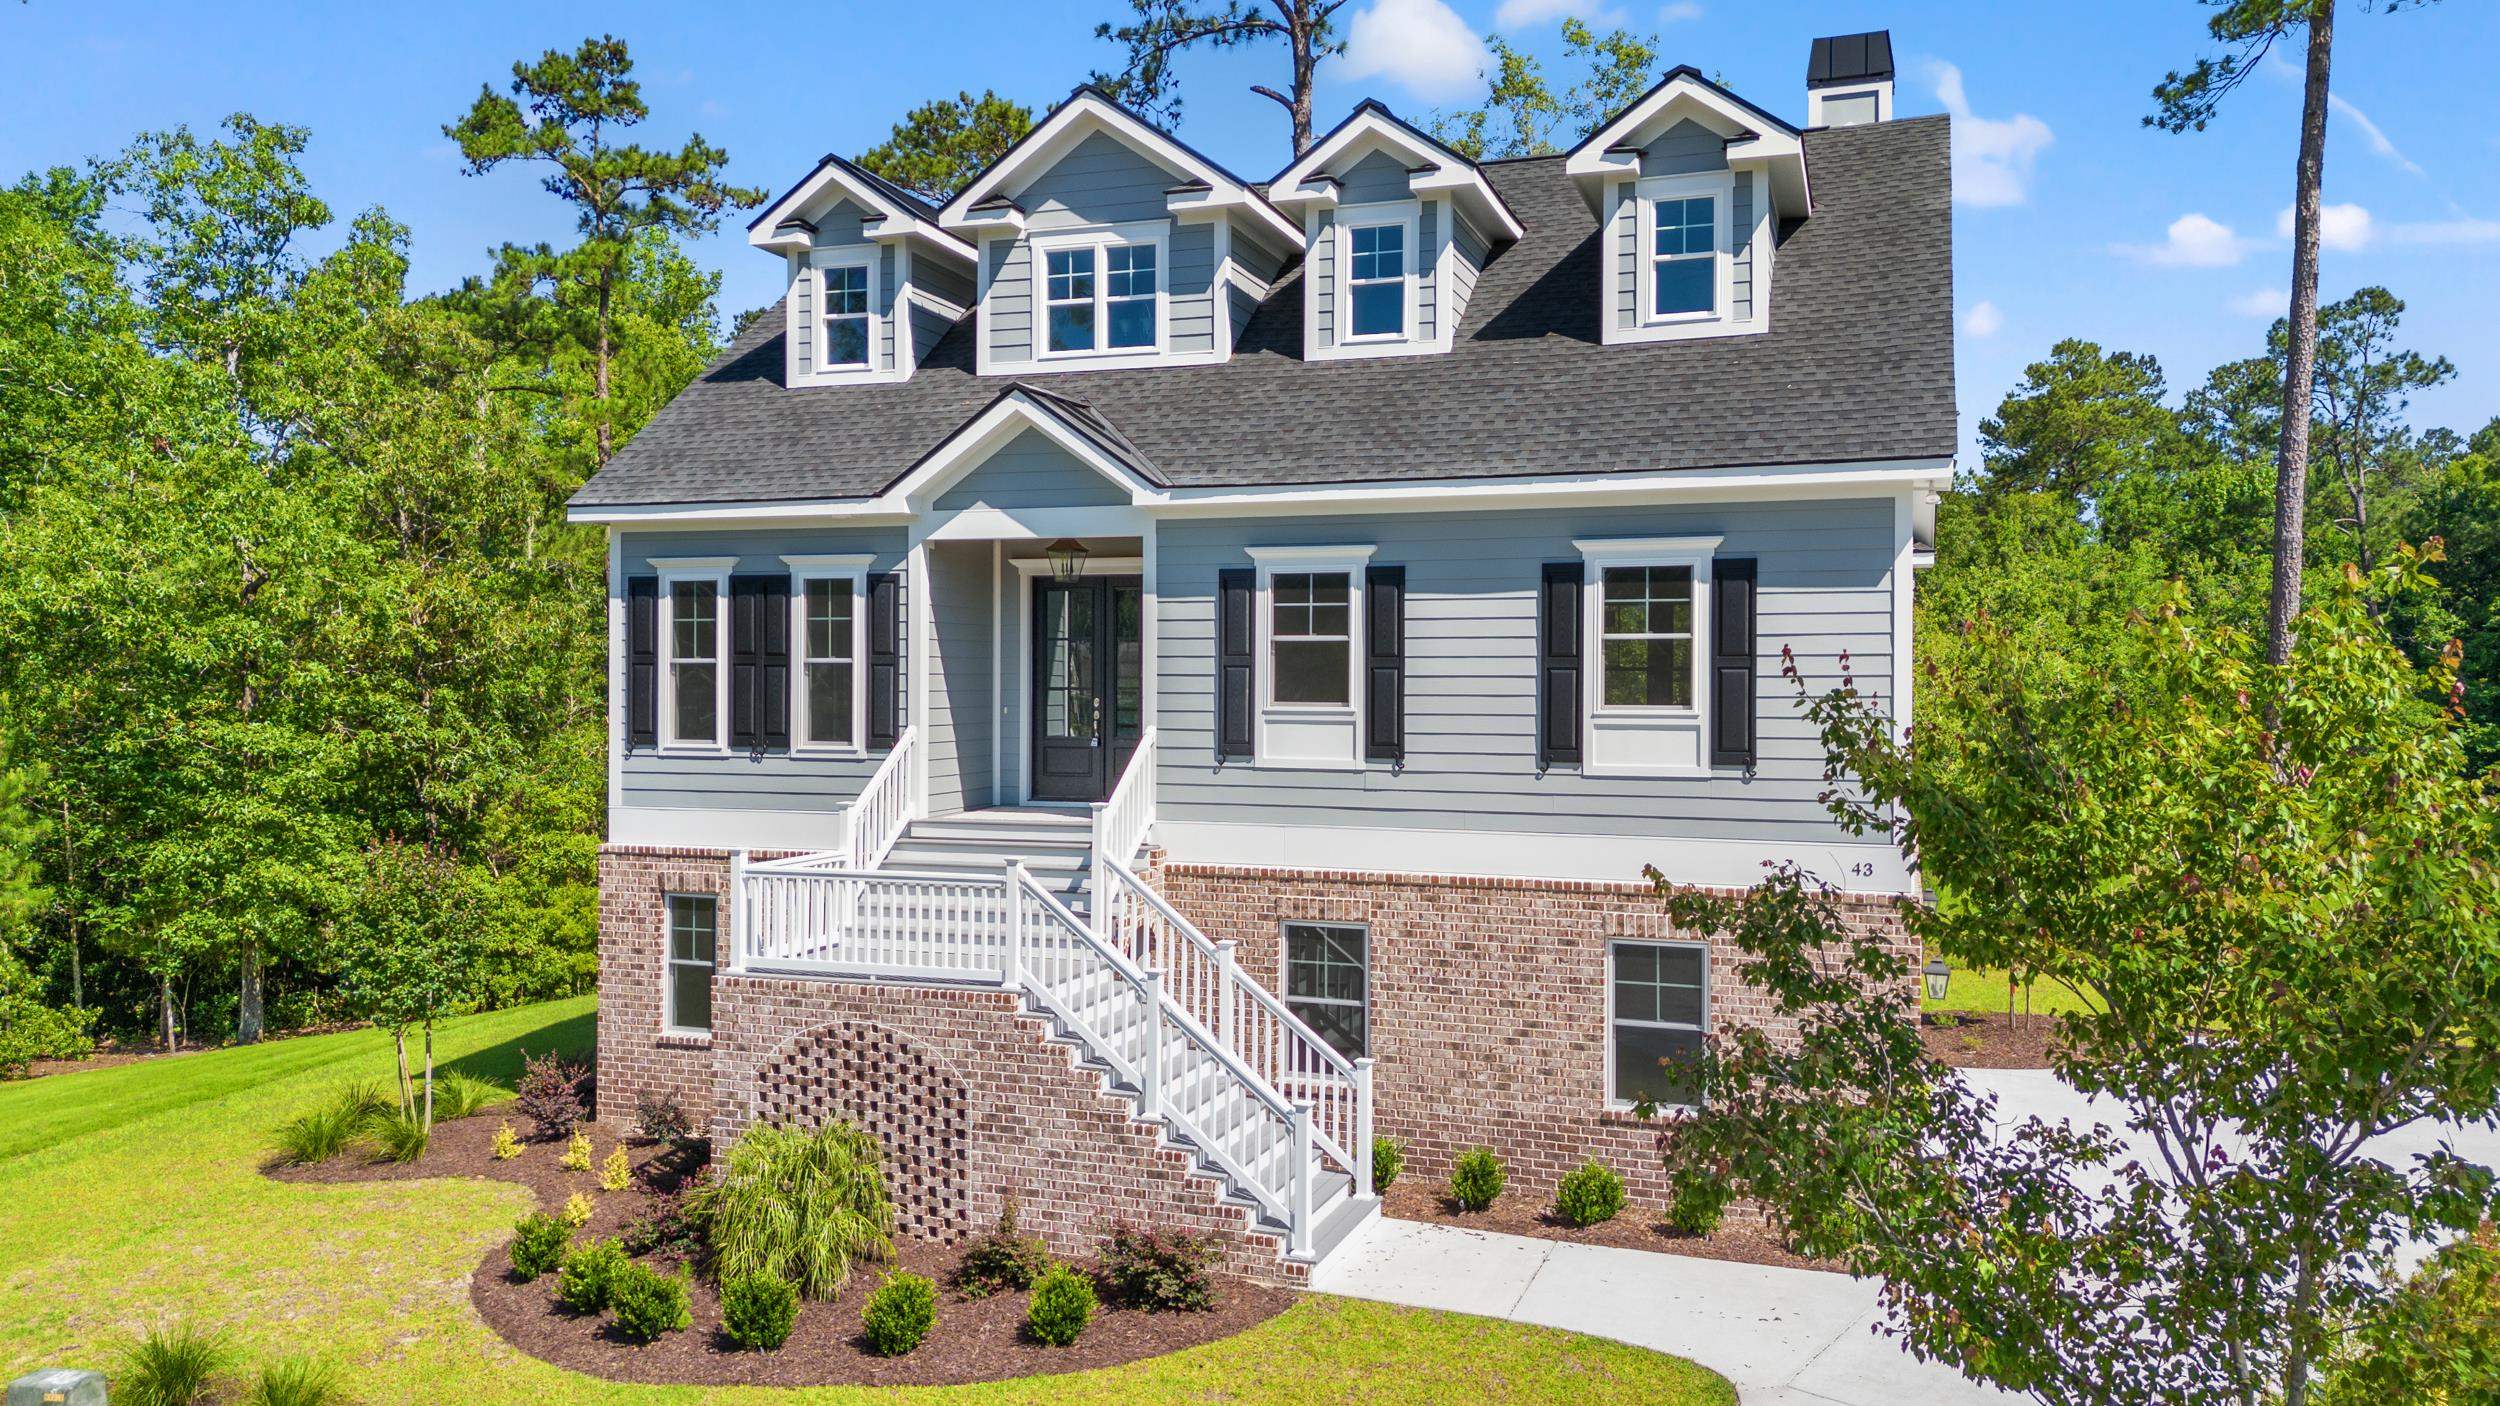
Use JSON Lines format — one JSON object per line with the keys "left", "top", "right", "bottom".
{"left": 1150, "top": 856, "right": 1915, "bottom": 1206}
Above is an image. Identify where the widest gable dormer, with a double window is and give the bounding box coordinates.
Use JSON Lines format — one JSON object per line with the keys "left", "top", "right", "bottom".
{"left": 938, "top": 88, "right": 1300, "bottom": 375}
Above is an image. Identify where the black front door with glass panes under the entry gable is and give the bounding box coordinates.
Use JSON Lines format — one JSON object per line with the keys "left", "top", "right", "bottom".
{"left": 1033, "top": 575, "right": 1145, "bottom": 801}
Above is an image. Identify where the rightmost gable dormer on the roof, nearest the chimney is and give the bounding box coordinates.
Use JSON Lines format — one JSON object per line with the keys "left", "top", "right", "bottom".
{"left": 1563, "top": 68, "right": 1813, "bottom": 343}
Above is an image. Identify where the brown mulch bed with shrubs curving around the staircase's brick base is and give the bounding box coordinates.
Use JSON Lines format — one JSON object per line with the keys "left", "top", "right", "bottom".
{"left": 270, "top": 1111, "right": 1295, "bottom": 1386}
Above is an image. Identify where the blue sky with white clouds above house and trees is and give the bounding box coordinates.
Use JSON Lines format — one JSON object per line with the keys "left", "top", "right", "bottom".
{"left": 0, "top": 0, "right": 2500, "bottom": 453}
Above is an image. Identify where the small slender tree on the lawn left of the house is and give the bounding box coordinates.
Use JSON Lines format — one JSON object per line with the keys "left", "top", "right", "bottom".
{"left": 338, "top": 841, "right": 480, "bottom": 1128}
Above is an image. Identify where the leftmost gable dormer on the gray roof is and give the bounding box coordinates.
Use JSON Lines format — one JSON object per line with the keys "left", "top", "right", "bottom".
{"left": 748, "top": 155, "right": 973, "bottom": 385}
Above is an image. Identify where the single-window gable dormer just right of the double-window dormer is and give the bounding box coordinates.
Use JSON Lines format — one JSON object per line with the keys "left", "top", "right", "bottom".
{"left": 1268, "top": 100, "right": 1525, "bottom": 360}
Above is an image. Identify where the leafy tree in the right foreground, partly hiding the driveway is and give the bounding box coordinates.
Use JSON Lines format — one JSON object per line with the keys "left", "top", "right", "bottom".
{"left": 1665, "top": 553, "right": 2500, "bottom": 1406}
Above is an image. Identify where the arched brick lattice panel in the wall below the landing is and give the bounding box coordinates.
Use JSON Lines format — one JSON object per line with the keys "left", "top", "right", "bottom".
{"left": 755, "top": 1021, "right": 973, "bottom": 1241}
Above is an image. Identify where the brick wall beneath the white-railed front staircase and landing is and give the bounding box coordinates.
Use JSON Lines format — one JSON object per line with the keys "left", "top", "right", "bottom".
{"left": 713, "top": 976, "right": 1300, "bottom": 1281}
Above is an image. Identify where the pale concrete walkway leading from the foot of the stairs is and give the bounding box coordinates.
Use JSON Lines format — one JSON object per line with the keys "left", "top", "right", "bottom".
{"left": 1310, "top": 1218, "right": 2015, "bottom": 1406}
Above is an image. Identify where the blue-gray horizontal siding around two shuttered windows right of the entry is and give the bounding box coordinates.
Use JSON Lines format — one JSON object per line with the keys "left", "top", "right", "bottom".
{"left": 1155, "top": 500, "right": 1893, "bottom": 843}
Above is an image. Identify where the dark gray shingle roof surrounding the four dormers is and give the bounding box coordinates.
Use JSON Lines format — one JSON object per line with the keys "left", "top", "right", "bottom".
{"left": 573, "top": 118, "right": 1955, "bottom": 508}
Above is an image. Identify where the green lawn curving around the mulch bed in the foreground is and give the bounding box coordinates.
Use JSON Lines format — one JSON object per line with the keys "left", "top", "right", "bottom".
{"left": 0, "top": 998, "right": 1735, "bottom": 1406}
